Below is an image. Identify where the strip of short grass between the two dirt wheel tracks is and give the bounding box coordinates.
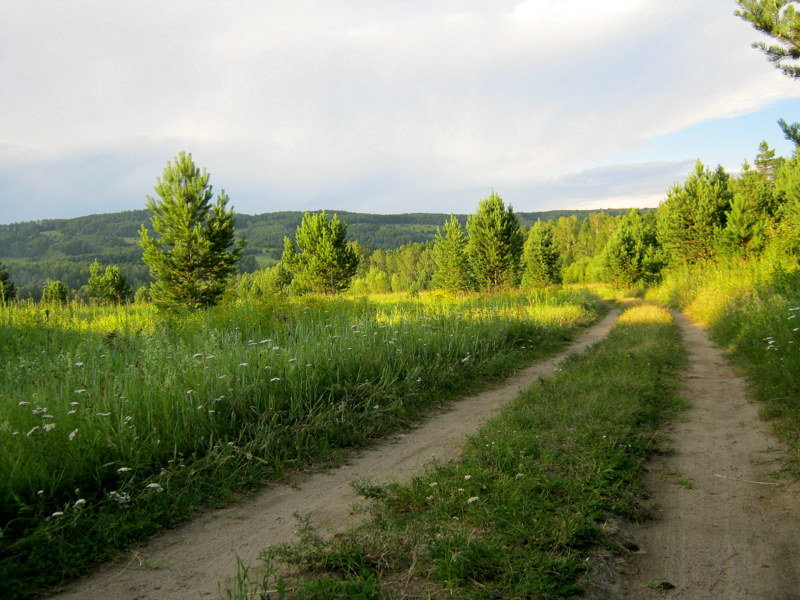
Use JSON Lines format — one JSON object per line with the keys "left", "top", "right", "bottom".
{"left": 223, "top": 305, "right": 683, "bottom": 600}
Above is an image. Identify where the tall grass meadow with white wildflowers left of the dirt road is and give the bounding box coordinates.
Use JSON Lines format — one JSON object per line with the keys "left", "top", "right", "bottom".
{"left": 0, "top": 291, "right": 604, "bottom": 598}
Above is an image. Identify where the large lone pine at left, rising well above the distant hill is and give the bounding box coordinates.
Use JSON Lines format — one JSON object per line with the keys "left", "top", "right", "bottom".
{"left": 139, "top": 152, "right": 244, "bottom": 309}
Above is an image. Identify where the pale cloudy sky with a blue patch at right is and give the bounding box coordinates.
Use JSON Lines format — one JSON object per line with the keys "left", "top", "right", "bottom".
{"left": 0, "top": 0, "right": 800, "bottom": 223}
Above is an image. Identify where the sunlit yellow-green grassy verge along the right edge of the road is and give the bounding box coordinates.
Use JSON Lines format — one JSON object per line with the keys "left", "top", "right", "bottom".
{"left": 649, "top": 259, "right": 800, "bottom": 468}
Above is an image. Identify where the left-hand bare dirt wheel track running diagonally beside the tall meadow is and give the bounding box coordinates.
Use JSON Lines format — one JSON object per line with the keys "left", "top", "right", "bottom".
{"left": 54, "top": 311, "right": 619, "bottom": 600}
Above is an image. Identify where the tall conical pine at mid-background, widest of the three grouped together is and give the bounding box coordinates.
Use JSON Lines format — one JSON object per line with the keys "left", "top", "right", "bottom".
{"left": 467, "top": 191, "right": 524, "bottom": 290}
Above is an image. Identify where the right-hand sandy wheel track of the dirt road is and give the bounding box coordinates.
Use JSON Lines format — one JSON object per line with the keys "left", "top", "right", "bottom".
{"left": 610, "top": 314, "right": 800, "bottom": 600}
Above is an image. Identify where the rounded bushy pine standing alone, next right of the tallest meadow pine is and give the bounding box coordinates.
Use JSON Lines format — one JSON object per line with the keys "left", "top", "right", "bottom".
{"left": 282, "top": 211, "right": 358, "bottom": 294}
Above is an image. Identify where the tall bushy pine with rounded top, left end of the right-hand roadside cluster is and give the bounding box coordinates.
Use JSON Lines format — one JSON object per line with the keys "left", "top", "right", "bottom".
{"left": 658, "top": 161, "right": 732, "bottom": 263}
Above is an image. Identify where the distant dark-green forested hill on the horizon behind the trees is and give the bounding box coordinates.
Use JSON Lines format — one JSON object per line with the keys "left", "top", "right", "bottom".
{"left": 0, "top": 209, "right": 626, "bottom": 297}
